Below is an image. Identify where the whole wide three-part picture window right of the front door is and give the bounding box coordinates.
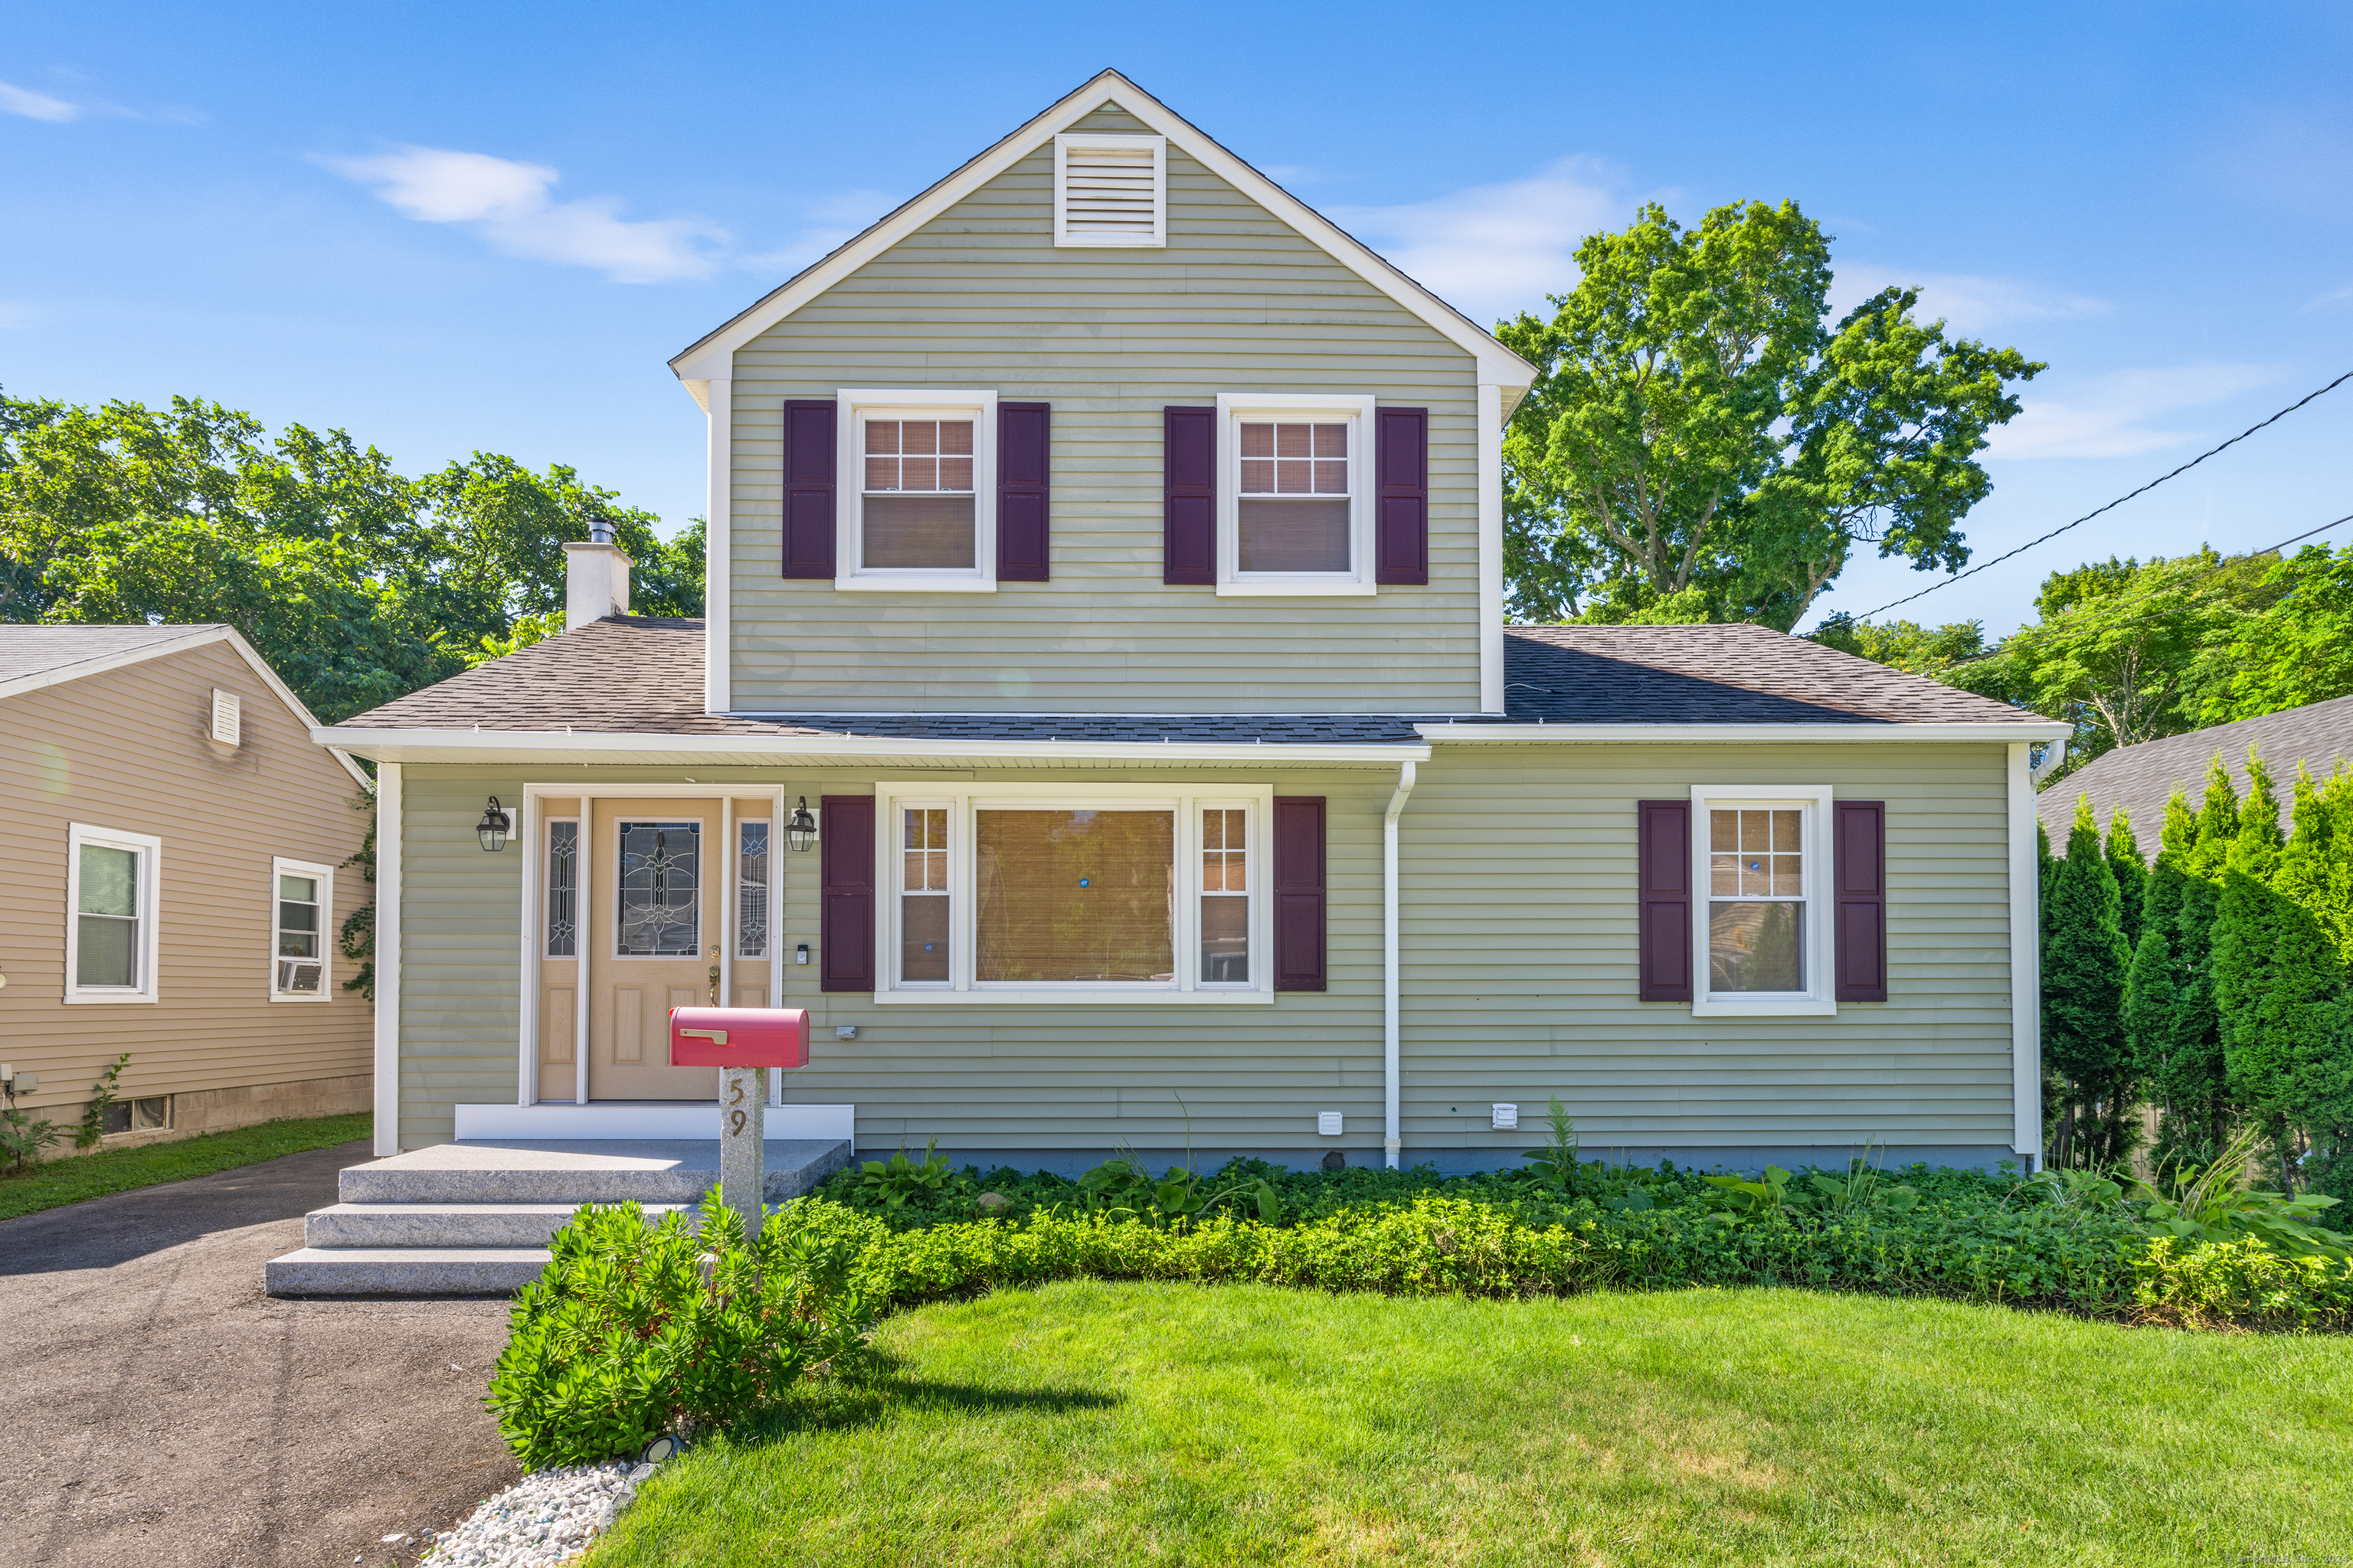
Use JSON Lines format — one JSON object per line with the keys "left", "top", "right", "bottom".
{"left": 878, "top": 784, "right": 1271, "bottom": 1000}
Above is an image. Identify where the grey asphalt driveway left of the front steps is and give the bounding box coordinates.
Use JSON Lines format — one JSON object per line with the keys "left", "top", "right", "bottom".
{"left": 0, "top": 1142, "right": 515, "bottom": 1568}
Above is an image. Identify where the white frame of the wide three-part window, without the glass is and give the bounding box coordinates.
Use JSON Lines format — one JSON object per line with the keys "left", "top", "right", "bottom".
{"left": 875, "top": 779, "right": 1275, "bottom": 1005}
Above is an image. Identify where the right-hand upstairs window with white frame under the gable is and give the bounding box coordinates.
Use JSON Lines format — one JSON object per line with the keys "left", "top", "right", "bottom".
{"left": 1216, "top": 393, "right": 1374, "bottom": 596}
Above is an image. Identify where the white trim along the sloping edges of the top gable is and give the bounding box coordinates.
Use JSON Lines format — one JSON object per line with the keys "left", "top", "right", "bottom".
{"left": 671, "top": 70, "right": 1536, "bottom": 393}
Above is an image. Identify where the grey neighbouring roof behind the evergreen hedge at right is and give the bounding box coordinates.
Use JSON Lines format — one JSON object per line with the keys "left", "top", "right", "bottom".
{"left": 2035, "top": 697, "right": 2353, "bottom": 859}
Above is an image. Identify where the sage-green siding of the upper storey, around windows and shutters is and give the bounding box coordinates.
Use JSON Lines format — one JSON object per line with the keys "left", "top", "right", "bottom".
{"left": 729, "top": 113, "right": 1478, "bottom": 713}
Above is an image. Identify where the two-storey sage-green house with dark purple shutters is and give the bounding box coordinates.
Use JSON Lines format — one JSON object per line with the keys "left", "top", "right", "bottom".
{"left": 316, "top": 73, "right": 2066, "bottom": 1167}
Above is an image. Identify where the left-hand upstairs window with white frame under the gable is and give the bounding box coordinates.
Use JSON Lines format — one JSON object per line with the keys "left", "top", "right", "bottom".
{"left": 836, "top": 391, "right": 998, "bottom": 594}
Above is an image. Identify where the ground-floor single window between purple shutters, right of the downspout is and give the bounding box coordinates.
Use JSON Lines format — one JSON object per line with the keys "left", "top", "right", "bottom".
{"left": 1692, "top": 787, "right": 1838, "bottom": 1015}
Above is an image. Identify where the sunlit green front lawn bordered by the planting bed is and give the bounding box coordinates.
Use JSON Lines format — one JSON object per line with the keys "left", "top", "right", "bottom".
{"left": 591, "top": 1283, "right": 2353, "bottom": 1568}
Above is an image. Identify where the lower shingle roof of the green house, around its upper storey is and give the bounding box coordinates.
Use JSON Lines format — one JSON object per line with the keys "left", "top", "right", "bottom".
{"left": 344, "top": 617, "right": 2021, "bottom": 744}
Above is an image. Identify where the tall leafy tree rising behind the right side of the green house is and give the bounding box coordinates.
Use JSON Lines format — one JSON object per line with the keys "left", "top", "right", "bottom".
{"left": 1499, "top": 202, "right": 2042, "bottom": 629}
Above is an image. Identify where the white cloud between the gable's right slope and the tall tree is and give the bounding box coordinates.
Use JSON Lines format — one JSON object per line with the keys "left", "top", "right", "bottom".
{"left": 1327, "top": 158, "right": 1638, "bottom": 322}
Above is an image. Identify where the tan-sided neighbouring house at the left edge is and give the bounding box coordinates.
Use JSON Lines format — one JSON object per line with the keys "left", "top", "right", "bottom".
{"left": 0, "top": 624, "right": 371, "bottom": 1147}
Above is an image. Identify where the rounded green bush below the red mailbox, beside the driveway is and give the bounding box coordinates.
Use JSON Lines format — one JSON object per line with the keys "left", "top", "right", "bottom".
{"left": 485, "top": 1203, "right": 871, "bottom": 1469}
